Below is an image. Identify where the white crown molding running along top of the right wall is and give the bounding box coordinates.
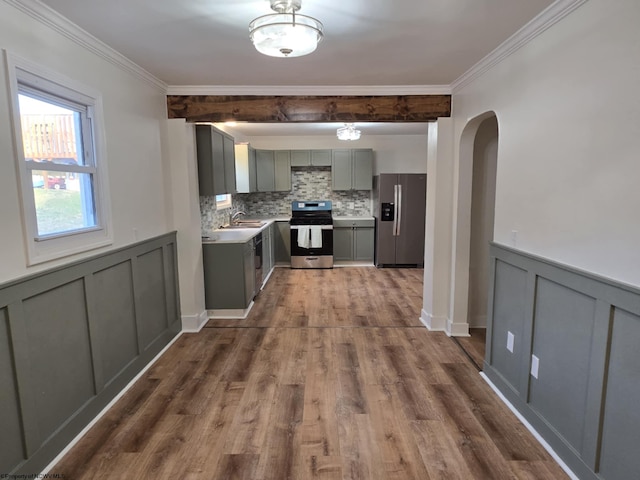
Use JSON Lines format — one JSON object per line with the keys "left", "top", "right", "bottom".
{"left": 450, "top": 0, "right": 588, "bottom": 94}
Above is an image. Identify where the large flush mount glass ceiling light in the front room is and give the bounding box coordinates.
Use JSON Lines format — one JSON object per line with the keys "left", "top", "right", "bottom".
{"left": 249, "top": 0, "right": 324, "bottom": 57}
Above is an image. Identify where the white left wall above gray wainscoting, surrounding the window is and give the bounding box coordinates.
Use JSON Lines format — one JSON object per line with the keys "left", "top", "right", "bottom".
{"left": 0, "top": 2, "right": 170, "bottom": 282}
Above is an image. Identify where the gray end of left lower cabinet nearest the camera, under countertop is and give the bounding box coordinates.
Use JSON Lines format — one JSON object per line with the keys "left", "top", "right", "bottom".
{"left": 202, "top": 239, "right": 255, "bottom": 310}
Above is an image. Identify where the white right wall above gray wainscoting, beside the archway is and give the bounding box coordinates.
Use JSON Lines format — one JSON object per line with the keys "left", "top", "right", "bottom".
{"left": 452, "top": 0, "right": 640, "bottom": 286}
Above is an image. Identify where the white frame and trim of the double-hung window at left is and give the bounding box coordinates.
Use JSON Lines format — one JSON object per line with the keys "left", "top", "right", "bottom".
{"left": 5, "top": 50, "right": 113, "bottom": 265}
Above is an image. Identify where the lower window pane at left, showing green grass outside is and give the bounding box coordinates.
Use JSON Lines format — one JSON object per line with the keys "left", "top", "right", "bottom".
{"left": 31, "top": 170, "right": 97, "bottom": 236}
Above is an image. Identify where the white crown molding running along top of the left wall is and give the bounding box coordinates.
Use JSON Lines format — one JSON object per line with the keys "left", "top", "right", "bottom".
{"left": 4, "top": 0, "right": 167, "bottom": 93}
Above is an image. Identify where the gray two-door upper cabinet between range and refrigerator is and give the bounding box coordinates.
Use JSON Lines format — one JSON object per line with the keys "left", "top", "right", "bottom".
{"left": 331, "top": 148, "right": 373, "bottom": 190}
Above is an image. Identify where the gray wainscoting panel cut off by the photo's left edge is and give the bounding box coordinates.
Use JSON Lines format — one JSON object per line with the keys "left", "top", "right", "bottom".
{"left": 0, "top": 308, "right": 24, "bottom": 473}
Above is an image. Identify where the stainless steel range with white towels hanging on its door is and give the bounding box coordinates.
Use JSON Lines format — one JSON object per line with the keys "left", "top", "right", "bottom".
{"left": 289, "top": 200, "right": 333, "bottom": 268}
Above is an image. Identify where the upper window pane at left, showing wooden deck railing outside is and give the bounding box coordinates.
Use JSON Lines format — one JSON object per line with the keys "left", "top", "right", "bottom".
{"left": 18, "top": 94, "right": 84, "bottom": 165}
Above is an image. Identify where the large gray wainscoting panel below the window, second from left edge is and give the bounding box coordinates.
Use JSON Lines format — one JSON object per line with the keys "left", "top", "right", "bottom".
{"left": 22, "top": 279, "right": 95, "bottom": 446}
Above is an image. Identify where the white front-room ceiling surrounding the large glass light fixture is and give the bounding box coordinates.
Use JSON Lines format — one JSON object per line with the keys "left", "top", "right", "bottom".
{"left": 37, "top": 0, "right": 553, "bottom": 134}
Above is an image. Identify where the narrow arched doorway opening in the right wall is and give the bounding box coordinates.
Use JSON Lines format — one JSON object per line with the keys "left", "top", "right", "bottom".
{"left": 447, "top": 112, "right": 498, "bottom": 336}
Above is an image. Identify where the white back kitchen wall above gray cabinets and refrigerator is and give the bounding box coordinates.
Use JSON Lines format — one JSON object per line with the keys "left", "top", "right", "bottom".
{"left": 238, "top": 133, "right": 427, "bottom": 175}
